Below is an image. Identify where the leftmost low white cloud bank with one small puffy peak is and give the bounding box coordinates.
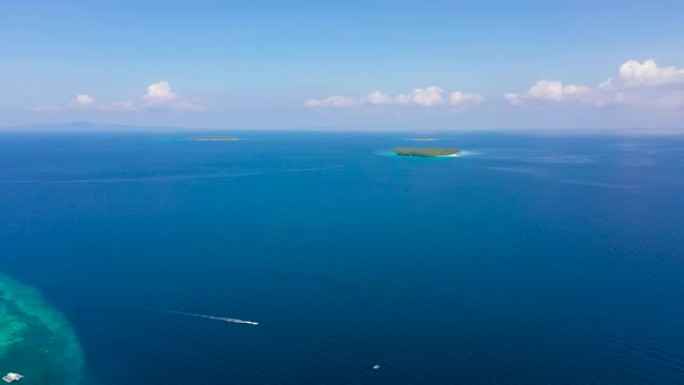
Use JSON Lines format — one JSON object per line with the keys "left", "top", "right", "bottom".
{"left": 31, "top": 80, "right": 206, "bottom": 112}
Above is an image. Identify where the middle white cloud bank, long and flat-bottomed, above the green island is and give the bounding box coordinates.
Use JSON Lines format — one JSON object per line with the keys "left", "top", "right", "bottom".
{"left": 304, "top": 86, "right": 484, "bottom": 107}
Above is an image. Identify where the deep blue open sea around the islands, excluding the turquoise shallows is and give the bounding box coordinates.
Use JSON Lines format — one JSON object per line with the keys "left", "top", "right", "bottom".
{"left": 0, "top": 132, "right": 684, "bottom": 385}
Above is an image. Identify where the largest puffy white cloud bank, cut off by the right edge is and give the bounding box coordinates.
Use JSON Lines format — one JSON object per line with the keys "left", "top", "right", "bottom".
{"left": 504, "top": 60, "right": 684, "bottom": 108}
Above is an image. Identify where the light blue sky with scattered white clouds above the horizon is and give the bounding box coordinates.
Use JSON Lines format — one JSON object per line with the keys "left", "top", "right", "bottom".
{"left": 0, "top": 0, "right": 684, "bottom": 130}
